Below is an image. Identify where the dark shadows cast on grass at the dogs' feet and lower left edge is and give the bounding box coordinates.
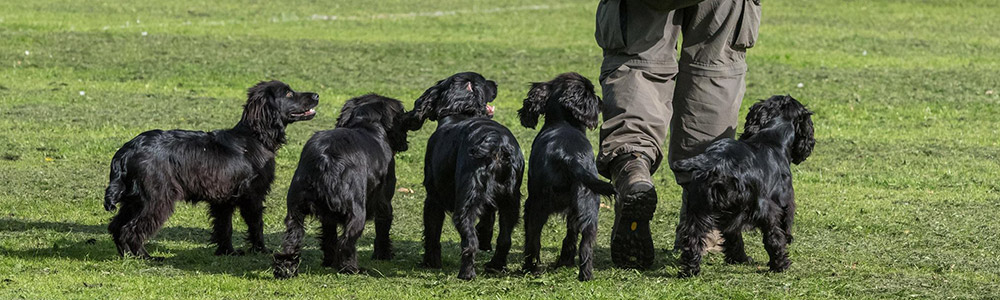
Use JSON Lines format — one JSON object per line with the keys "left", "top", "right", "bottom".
{"left": 0, "top": 218, "right": 677, "bottom": 279}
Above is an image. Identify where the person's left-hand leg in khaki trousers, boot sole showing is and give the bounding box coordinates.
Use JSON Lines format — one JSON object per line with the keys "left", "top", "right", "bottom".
{"left": 597, "top": 1, "right": 680, "bottom": 269}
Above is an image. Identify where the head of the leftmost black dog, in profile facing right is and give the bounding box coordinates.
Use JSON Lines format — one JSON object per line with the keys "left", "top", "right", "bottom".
{"left": 243, "top": 80, "right": 319, "bottom": 124}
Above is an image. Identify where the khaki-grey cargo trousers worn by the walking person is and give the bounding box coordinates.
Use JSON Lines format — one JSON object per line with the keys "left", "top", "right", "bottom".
{"left": 595, "top": 0, "right": 761, "bottom": 184}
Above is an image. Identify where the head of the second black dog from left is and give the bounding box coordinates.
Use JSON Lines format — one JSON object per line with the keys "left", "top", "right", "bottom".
{"left": 337, "top": 94, "right": 409, "bottom": 152}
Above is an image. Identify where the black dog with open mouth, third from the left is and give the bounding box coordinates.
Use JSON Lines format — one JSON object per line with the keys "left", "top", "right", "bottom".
{"left": 407, "top": 72, "right": 524, "bottom": 280}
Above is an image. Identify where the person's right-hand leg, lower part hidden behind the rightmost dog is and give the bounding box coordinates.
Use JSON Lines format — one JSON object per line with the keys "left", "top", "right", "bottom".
{"left": 667, "top": 0, "right": 760, "bottom": 250}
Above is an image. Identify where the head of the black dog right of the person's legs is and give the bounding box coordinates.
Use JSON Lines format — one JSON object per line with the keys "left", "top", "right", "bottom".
{"left": 740, "top": 95, "right": 816, "bottom": 164}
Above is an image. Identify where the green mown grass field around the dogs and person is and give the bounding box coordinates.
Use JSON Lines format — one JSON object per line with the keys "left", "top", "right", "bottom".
{"left": 0, "top": 0, "right": 1000, "bottom": 299}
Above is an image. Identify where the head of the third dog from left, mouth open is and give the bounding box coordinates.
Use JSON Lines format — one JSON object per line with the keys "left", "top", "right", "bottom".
{"left": 406, "top": 72, "right": 497, "bottom": 130}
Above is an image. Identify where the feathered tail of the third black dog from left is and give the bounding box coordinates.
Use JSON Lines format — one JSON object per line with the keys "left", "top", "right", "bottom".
{"left": 469, "top": 131, "right": 524, "bottom": 209}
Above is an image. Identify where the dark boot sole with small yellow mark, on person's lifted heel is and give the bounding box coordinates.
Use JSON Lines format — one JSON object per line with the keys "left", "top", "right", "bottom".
{"left": 611, "top": 187, "right": 656, "bottom": 269}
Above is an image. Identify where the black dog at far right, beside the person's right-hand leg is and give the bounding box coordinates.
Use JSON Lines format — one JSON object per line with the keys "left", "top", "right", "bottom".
{"left": 670, "top": 96, "right": 816, "bottom": 277}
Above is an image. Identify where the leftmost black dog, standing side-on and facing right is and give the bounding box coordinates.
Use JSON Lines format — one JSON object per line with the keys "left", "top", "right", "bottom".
{"left": 104, "top": 81, "right": 319, "bottom": 259}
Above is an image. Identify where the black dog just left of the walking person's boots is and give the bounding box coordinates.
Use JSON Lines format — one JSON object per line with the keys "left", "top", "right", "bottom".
{"left": 517, "top": 73, "right": 615, "bottom": 281}
